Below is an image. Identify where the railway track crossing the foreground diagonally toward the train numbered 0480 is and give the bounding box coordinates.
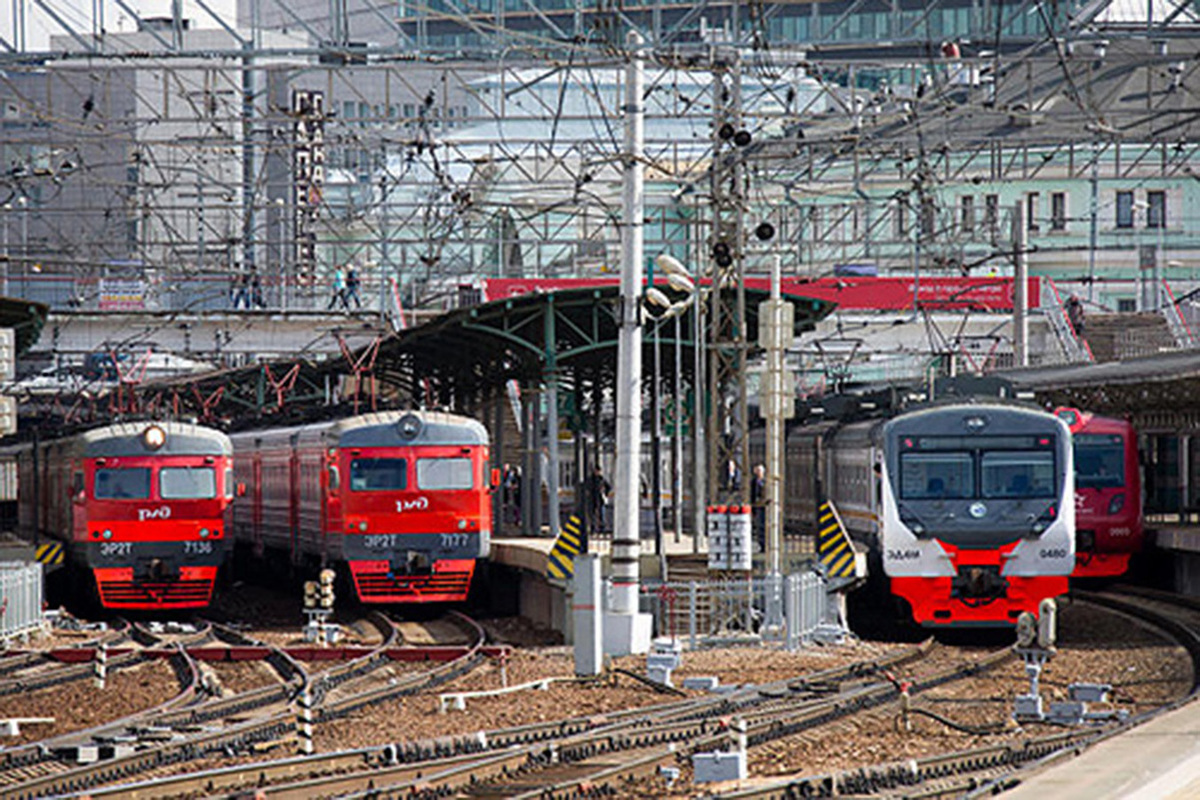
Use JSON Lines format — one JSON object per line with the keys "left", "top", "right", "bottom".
{"left": 79, "top": 644, "right": 945, "bottom": 798}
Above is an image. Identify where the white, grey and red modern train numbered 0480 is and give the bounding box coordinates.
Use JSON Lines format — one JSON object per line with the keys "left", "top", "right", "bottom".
{"left": 784, "top": 401, "right": 1075, "bottom": 628}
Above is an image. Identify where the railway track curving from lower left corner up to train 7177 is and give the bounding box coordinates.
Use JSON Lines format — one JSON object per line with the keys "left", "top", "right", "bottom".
{"left": 0, "top": 615, "right": 484, "bottom": 799}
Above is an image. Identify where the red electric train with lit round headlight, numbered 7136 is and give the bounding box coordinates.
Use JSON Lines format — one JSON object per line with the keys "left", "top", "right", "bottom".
{"left": 6, "top": 421, "right": 234, "bottom": 610}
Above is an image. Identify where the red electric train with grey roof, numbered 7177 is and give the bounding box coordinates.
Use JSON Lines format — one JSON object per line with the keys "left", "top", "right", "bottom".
{"left": 233, "top": 411, "right": 498, "bottom": 603}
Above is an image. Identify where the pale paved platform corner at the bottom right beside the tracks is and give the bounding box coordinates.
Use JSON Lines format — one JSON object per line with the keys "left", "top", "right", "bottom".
{"left": 1003, "top": 700, "right": 1200, "bottom": 800}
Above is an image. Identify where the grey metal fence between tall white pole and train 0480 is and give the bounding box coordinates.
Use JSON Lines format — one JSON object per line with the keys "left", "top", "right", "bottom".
{"left": 643, "top": 571, "right": 830, "bottom": 650}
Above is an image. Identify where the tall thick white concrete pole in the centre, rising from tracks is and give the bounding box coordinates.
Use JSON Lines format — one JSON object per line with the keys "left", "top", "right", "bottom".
{"left": 605, "top": 31, "right": 649, "bottom": 655}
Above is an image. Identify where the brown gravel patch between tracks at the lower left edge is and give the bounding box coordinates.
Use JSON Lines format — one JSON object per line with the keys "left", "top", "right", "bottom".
{"left": 0, "top": 658, "right": 180, "bottom": 746}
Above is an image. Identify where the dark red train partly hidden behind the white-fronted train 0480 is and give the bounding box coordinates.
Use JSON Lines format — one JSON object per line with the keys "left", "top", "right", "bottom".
{"left": 1055, "top": 408, "right": 1145, "bottom": 578}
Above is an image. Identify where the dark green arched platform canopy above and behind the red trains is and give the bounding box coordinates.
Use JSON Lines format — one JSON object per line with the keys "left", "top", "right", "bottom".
{"left": 28, "top": 284, "right": 835, "bottom": 428}
